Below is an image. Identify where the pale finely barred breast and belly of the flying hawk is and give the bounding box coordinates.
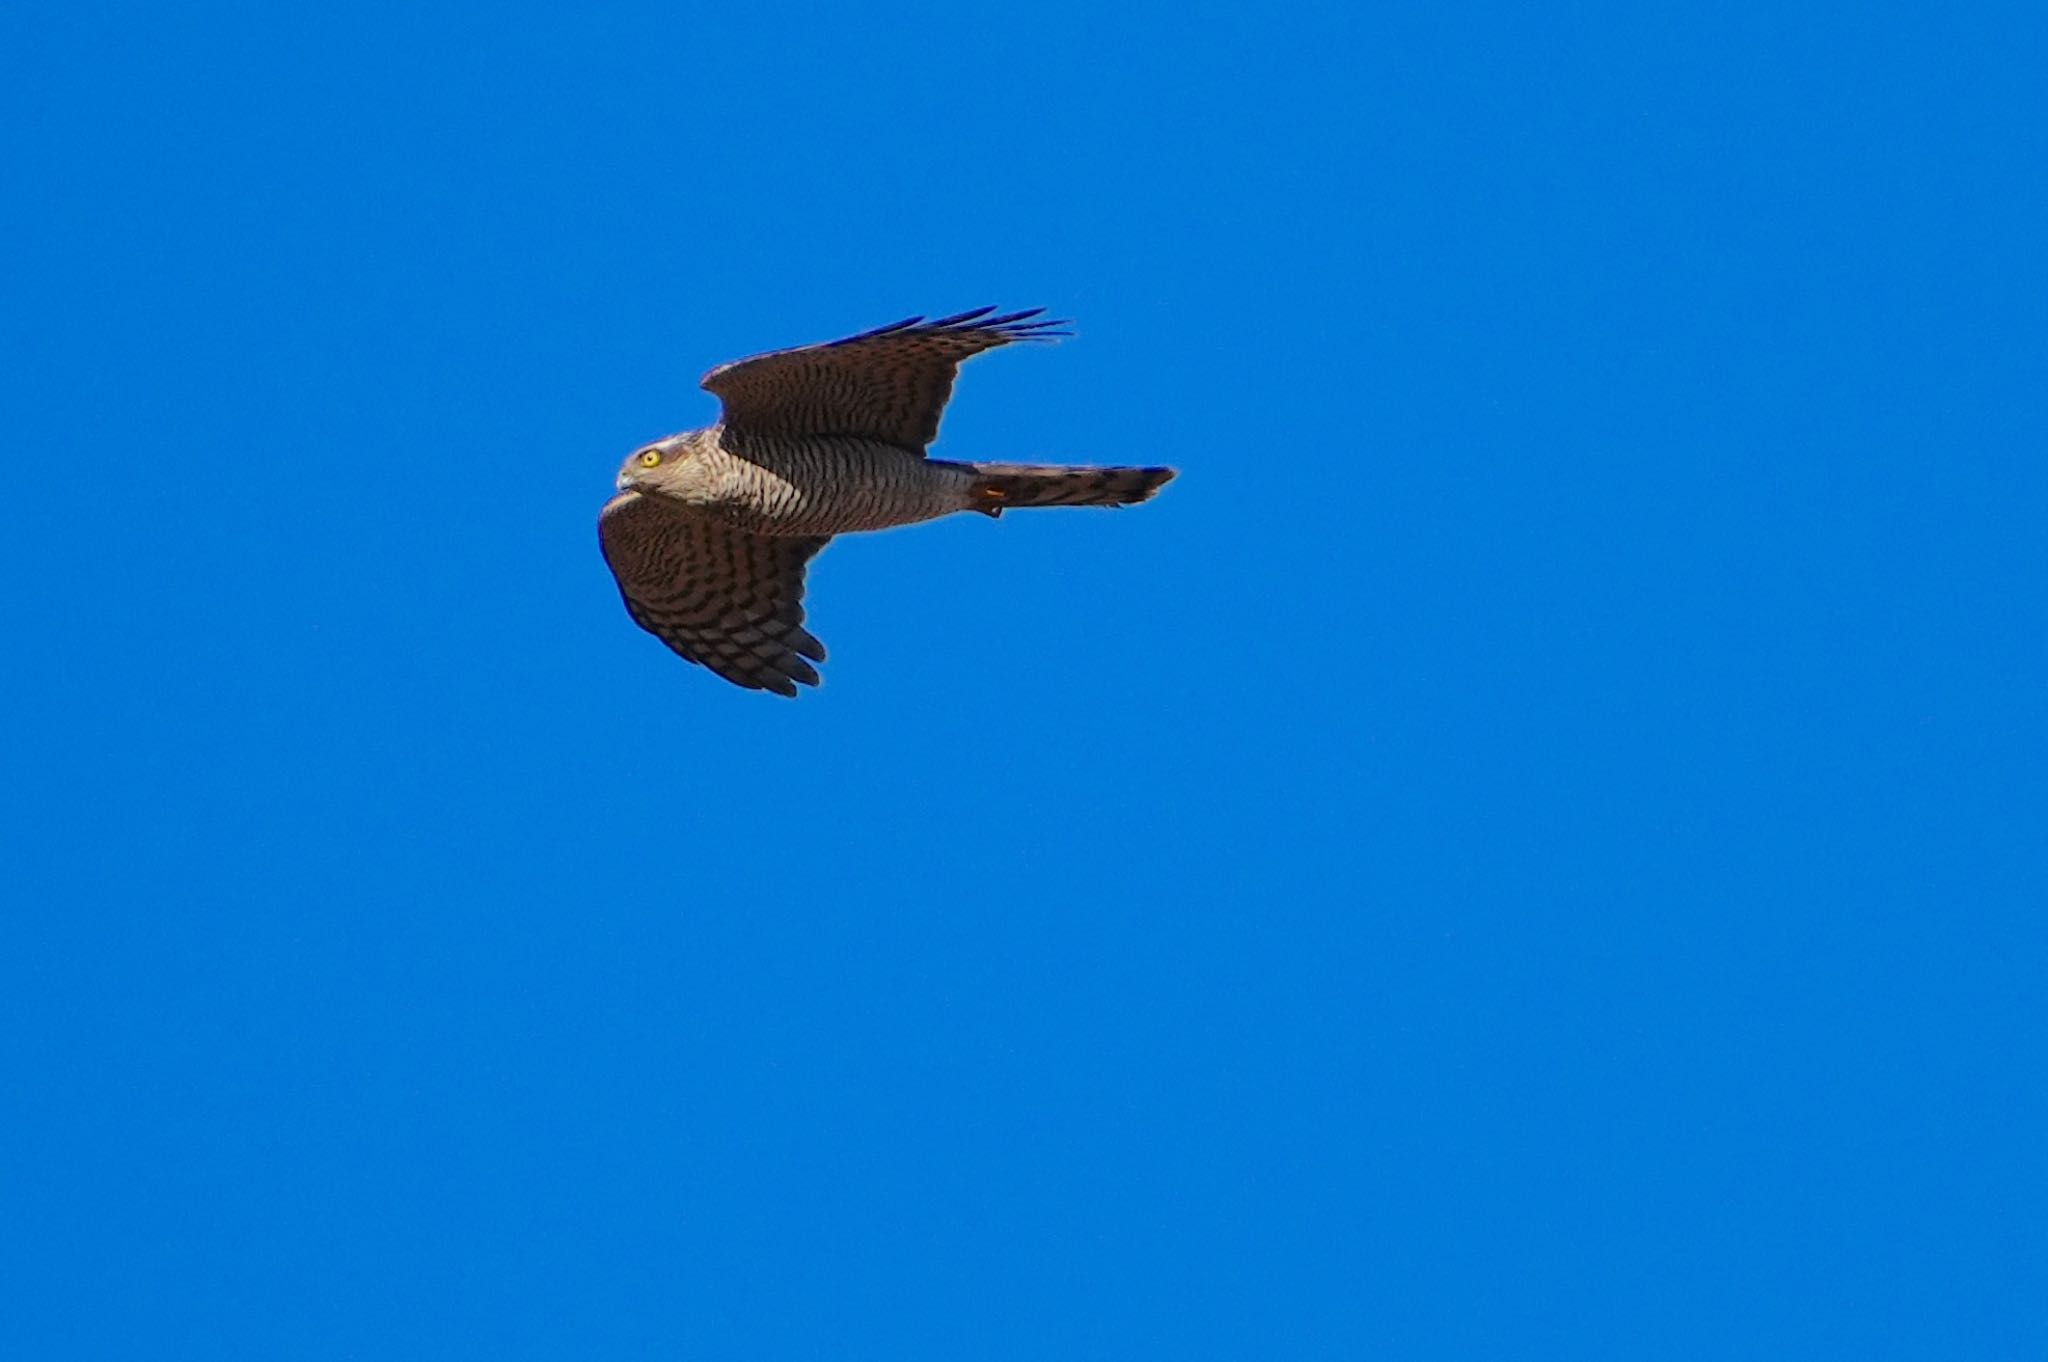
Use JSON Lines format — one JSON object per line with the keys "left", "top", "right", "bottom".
{"left": 711, "top": 430, "right": 973, "bottom": 535}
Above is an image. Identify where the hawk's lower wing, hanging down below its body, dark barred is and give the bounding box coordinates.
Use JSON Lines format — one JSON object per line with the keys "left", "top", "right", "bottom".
{"left": 598, "top": 492, "right": 827, "bottom": 694}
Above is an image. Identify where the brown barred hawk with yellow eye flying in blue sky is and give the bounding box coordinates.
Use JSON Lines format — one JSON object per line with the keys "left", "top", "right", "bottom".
{"left": 598, "top": 307, "right": 1174, "bottom": 696}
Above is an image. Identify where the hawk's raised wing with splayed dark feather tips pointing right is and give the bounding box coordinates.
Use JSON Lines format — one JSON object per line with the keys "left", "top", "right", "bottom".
{"left": 705, "top": 307, "right": 1069, "bottom": 455}
